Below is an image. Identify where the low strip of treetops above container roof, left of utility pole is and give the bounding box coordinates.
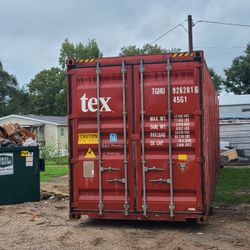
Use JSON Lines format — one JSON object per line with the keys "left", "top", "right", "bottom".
{"left": 119, "top": 43, "right": 180, "bottom": 56}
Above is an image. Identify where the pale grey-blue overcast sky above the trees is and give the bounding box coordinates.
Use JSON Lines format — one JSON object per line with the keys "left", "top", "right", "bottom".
{"left": 0, "top": 0, "right": 250, "bottom": 85}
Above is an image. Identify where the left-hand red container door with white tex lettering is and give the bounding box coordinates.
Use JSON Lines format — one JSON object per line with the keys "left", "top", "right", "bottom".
{"left": 72, "top": 62, "right": 133, "bottom": 214}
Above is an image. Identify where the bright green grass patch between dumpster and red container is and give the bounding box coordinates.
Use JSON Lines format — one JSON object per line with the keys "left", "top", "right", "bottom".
{"left": 40, "top": 165, "right": 68, "bottom": 182}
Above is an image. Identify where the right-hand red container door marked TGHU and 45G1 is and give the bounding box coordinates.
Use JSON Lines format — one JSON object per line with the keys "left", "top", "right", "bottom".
{"left": 134, "top": 60, "right": 202, "bottom": 217}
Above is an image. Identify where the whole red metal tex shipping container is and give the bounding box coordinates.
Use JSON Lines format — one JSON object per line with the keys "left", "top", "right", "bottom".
{"left": 67, "top": 51, "right": 219, "bottom": 222}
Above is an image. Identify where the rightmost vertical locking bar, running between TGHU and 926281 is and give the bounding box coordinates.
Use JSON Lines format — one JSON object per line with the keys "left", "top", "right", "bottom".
{"left": 166, "top": 59, "right": 175, "bottom": 218}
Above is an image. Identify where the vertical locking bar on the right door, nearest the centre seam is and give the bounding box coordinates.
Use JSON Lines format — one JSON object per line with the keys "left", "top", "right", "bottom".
{"left": 139, "top": 60, "right": 148, "bottom": 217}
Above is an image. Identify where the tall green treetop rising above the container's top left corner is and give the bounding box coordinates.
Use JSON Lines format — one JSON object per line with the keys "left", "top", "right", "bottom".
{"left": 59, "top": 38, "right": 102, "bottom": 69}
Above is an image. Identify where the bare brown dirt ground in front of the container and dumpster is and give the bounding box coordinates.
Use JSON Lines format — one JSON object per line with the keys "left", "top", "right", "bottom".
{"left": 0, "top": 199, "right": 250, "bottom": 250}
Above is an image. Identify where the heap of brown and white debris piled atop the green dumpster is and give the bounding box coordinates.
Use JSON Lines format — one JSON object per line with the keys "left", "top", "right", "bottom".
{"left": 0, "top": 123, "right": 38, "bottom": 147}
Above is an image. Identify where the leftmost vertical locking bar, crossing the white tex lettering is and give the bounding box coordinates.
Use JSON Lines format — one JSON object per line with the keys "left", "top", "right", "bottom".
{"left": 96, "top": 62, "right": 104, "bottom": 215}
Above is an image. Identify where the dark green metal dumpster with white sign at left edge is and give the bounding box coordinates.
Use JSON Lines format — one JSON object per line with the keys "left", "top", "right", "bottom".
{"left": 0, "top": 146, "right": 43, "bottom": 205}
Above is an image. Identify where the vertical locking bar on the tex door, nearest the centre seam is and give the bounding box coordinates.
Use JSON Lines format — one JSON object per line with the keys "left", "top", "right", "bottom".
{"left": 121, "top": 61, "right": 129, "bottom": 216}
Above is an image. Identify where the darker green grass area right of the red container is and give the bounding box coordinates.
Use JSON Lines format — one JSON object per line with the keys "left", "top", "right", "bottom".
{"left": 213, "top": 168, "right": 250, "bottom": 205}
